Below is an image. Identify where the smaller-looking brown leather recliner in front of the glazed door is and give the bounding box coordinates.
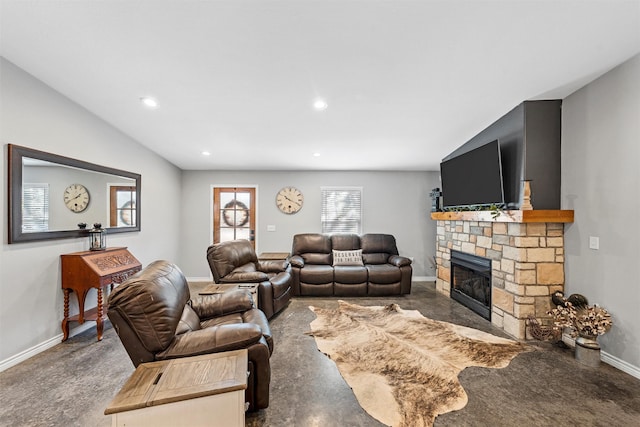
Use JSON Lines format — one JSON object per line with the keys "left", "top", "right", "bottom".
{"left": 207, "top": 240, "right": 292, "bottom": 319}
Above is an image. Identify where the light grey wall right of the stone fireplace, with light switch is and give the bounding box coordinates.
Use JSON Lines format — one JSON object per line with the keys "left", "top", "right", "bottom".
{"left": 562, "top": 55, "right": 640, "bottom": 373}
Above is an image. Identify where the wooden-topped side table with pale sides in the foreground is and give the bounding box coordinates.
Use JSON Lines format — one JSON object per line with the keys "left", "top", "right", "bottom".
{"left": 104, "top": 349, "right": 248, "bottom": 427}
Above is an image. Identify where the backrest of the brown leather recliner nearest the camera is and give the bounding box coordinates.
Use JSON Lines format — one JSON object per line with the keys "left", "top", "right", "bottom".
{"left": 108, "top": 261, "right": 190, "bottom": 353}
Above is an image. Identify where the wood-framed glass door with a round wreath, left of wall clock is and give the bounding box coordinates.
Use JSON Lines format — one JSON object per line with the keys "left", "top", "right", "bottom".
{"left": 213, "top": 187, "right": 256, "bottom": 249}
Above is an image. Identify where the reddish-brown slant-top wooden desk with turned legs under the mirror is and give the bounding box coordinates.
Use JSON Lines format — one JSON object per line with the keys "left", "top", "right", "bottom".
{"left": 60, "top": 248, "right": 142, "bottom": 341}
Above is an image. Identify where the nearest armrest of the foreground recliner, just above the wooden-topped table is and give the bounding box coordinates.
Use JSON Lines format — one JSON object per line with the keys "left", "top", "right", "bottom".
{"left": 156, "top": 323, "right": 262, "bottom": 360}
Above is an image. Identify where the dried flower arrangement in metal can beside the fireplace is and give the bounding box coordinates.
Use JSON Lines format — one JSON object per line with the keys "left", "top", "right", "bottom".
{"left": 547, "top": 292, "right": 613, "bottom": 366}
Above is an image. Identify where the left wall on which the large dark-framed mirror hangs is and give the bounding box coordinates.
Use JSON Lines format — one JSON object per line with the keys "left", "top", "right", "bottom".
{"left": 0, "top": 58, "right": 181, "bottom": 369}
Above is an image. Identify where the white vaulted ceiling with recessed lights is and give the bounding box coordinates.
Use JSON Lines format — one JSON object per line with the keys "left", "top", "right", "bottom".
{"left": 0, "top": 0, "right": 640, "bottom": 170}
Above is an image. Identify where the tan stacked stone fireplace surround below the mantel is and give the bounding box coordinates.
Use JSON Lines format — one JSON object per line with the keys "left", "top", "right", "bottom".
{"left": 436, "top": 220, "right": 564, "bottom": 339}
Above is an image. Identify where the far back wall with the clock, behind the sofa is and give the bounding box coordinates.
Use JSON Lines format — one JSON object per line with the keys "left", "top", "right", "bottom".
{"left": 180, "top": 171, "right": 440, "bottom": 278}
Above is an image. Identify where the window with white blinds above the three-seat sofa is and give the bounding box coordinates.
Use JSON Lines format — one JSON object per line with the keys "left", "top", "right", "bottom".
{"left": 320, "top": 187, "right": 362, "bottom": 234}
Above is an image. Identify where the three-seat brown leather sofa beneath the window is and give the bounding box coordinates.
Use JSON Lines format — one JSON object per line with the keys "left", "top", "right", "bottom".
{"left": 289, "top": 233, "right": 412, "bottom": 297}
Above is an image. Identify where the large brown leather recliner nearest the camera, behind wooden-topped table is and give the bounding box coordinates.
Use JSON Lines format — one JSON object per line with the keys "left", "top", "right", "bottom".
{"left": 107, "top": 261, "right": 273, "bottom": 410}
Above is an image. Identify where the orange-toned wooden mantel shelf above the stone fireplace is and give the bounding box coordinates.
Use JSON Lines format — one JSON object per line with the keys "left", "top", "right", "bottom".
{"left": 431, "top": 210, "right": 573, "bottom": 223}
